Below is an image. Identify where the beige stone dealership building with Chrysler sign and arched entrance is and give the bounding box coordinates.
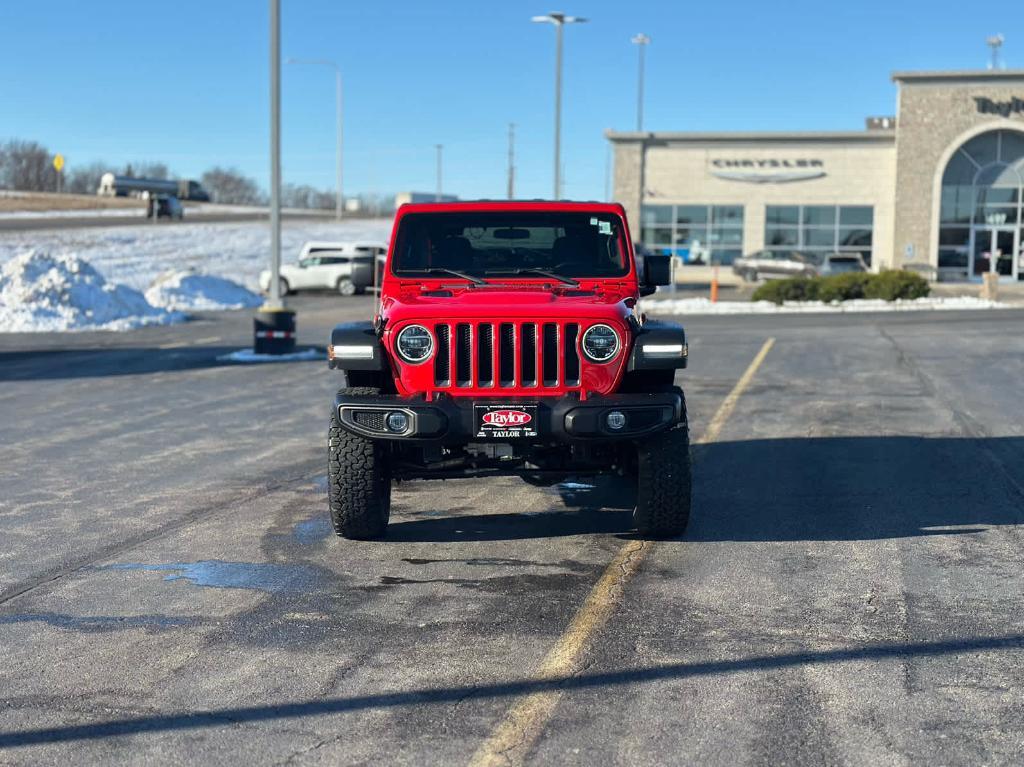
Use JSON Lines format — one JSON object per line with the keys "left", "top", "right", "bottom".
{"left": 607, "top": 71, "right": 1024, "bottom": 282}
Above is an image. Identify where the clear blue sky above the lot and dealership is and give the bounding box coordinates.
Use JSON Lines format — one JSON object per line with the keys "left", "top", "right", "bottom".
{"left": 0, "top": 0, "right": 1024, "bottom": 198}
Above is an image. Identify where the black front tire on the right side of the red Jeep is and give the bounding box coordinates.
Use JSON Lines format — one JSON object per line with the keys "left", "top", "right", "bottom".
{"left": 633, "top": 400, "right": 691, "bottom": 538}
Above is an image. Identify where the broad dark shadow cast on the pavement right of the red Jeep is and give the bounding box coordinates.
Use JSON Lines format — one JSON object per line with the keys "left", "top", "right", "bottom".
{"left": 684, "top": 436, "right": 1024, "bottom": 542}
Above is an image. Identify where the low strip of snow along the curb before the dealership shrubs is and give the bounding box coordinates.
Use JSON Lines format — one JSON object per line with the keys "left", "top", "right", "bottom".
{"left": 640, "top": 296, "right": 1011, "bottom": 314}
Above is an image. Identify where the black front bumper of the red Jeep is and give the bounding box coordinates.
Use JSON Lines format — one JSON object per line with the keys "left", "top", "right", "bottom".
{"left": 334, "top": 389, "right": 683, "bottom": 444}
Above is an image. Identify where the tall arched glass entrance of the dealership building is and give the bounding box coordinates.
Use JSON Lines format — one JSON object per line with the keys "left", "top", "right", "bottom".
{"left": 939, "top": 129, "right": 1024, "bottom": 281}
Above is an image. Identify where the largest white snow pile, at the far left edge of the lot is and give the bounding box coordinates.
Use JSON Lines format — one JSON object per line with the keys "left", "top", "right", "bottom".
{"left": 0, "top": 250, "right": 186, "bottom": 333}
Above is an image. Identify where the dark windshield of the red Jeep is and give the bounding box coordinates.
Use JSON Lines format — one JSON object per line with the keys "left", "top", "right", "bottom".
{"left": 391, "top": 211, "right": 630, "bottom": 279}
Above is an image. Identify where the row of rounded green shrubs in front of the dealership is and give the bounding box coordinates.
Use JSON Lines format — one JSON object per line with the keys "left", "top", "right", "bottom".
{"left": 751, "top": 271, "right": 931, "bottom": 304}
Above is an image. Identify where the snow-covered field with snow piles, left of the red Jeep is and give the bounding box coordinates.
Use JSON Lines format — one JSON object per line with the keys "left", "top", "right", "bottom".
{"left": 0, "top": 220, "right": 390, "bottom": 333}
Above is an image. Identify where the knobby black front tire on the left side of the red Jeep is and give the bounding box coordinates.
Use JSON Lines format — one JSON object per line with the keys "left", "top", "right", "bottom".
{"left": 328, "top": 387, "right": 391, "bottom": 541}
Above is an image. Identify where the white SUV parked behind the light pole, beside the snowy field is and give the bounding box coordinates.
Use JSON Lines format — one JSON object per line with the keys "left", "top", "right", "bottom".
{"left": 259, "top": 243, "right": 387, "bottom": 296}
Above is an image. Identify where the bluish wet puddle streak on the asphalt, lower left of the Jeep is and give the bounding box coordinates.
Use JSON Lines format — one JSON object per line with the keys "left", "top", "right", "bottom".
{"left": 97, "top": 559, "right": 318, "bottom": 593}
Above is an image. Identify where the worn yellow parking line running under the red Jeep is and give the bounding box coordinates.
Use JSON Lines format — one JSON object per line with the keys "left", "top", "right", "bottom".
{"left": 469, "top": 338, "right": 775, "bottom": 767}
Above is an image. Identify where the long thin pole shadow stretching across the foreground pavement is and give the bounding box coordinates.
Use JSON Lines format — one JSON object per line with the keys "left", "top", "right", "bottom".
{"left": 0, "top": 634, "right": 1024, "bottom": 749}
